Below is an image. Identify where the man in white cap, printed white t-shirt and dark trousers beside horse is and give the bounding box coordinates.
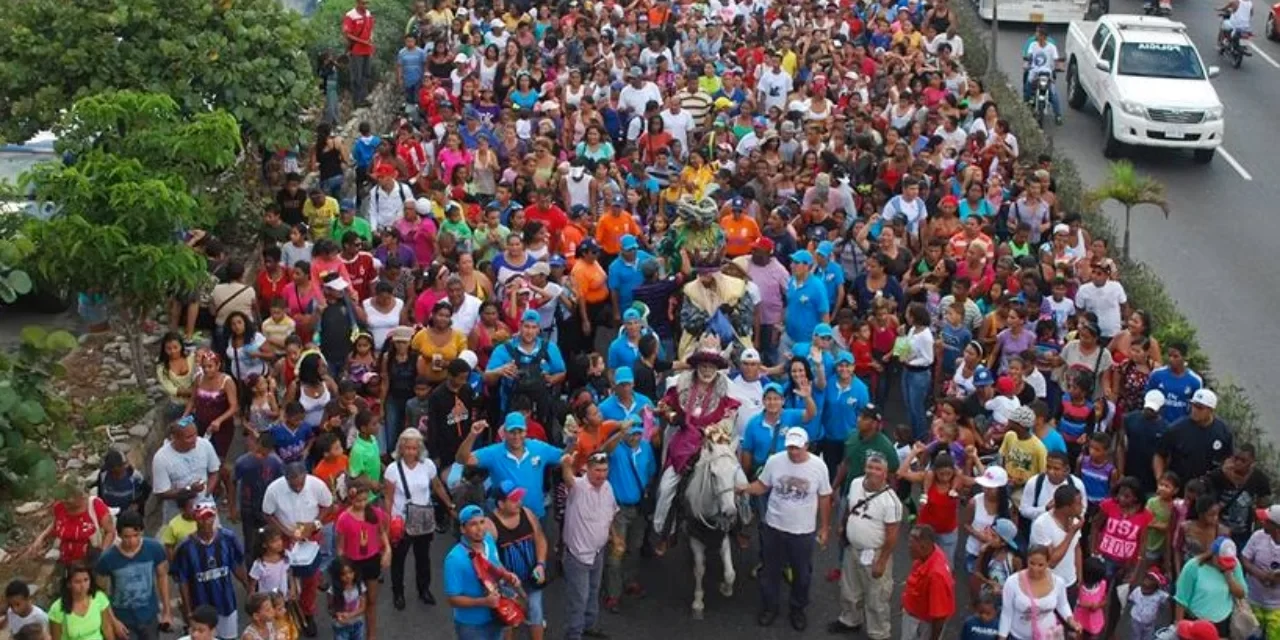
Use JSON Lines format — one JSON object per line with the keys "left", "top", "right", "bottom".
{"left": 740, "top": 426, "right": 832, "bottom": 631}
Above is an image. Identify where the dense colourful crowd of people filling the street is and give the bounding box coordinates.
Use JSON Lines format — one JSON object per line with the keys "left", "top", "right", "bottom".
{"left": 5, "top": 0, "right": 1280, "bottom": 640}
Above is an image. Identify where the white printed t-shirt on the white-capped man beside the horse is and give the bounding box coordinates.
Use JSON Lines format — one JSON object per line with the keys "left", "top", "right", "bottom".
{"left": 760, "top": 452, "right": 831, "bottom": 535}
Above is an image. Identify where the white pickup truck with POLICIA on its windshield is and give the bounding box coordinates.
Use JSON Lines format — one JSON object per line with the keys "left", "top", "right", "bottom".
{"left": 1064, "top": 14, "right": 1222, "bottom": 164}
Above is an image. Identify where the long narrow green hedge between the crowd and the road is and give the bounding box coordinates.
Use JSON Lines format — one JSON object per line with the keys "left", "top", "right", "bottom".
{"left": 954, "top": 3, "right": 1280, "bottom": 489}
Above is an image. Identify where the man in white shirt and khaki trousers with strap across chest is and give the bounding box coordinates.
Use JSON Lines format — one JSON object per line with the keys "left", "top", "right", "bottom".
{"left": 827, "top": 451, "right": 902, "bottom": 640}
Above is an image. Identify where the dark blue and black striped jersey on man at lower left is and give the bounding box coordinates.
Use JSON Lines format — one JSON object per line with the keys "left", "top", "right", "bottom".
{"left": 169, "top": 527, "right": 244, "bottom": 616}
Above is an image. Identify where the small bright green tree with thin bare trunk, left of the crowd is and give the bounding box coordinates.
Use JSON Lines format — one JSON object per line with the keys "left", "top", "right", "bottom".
{"left": 20, "top": 91, "right": 241, "bottom": 385}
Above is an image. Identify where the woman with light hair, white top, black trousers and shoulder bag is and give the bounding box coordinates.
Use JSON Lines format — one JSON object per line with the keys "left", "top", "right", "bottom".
{"left": 383, "top": 428, "right": 453, "bottom": 611}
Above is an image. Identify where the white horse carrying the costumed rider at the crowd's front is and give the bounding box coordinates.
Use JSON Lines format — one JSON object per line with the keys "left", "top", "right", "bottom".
{"left": 685, "top": 422, "right": 746, "bottom": 620}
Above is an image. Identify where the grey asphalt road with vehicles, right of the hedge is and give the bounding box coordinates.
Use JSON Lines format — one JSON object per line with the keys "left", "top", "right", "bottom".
{"left": 977, "top": 0, "right": 1280, "bottom": 436}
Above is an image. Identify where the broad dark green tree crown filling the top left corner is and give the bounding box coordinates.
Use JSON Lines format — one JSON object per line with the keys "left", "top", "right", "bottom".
{"left": 0, "top": 0, "right": 319, "bottom": 148}
